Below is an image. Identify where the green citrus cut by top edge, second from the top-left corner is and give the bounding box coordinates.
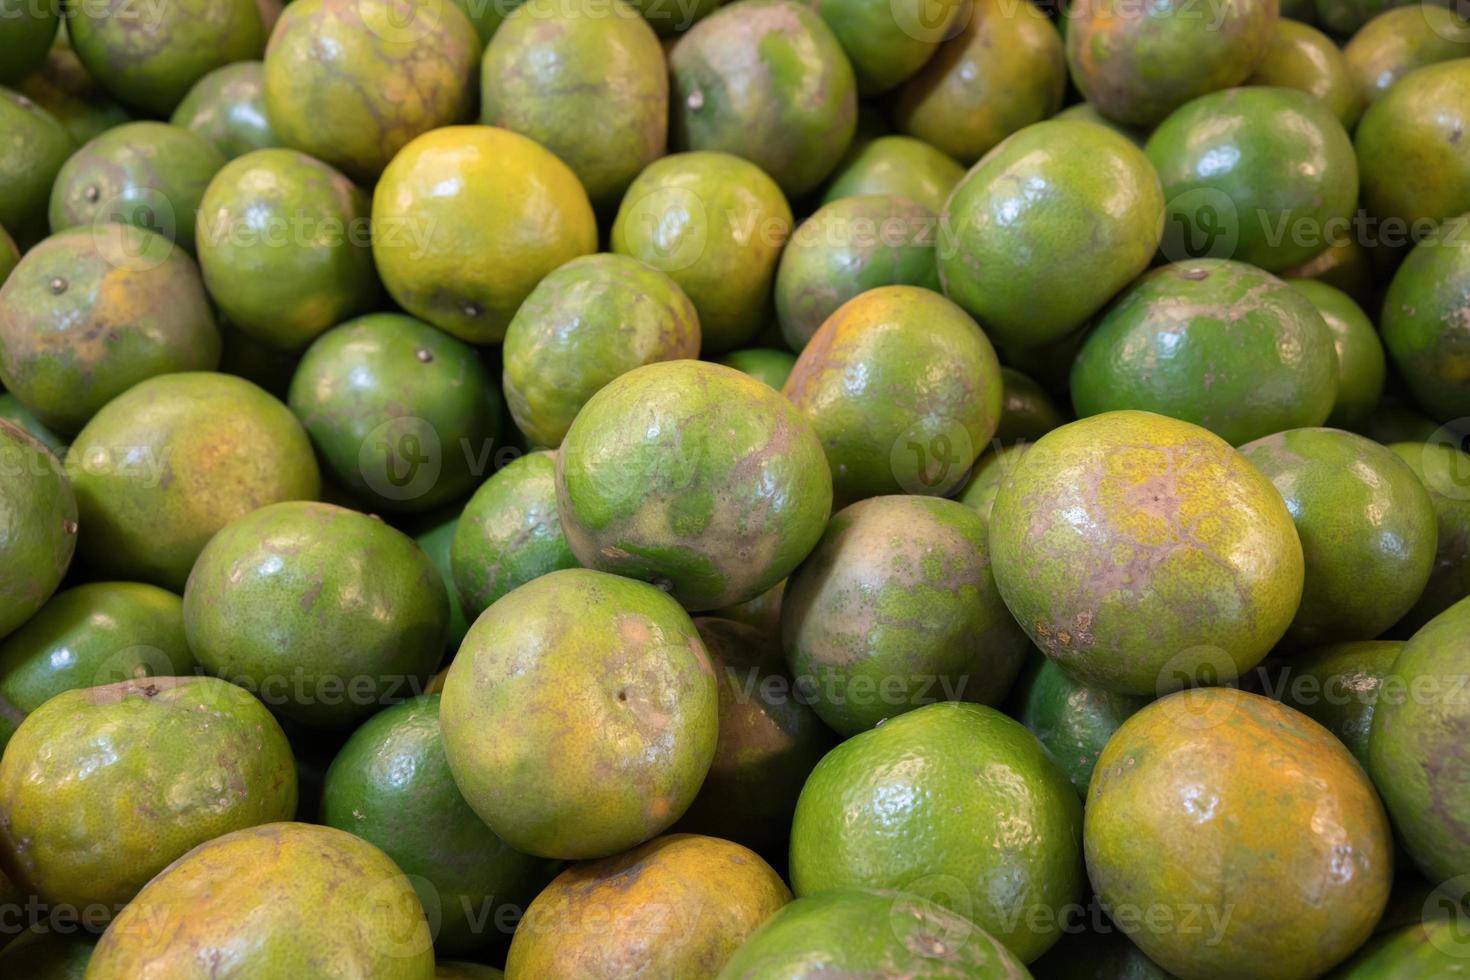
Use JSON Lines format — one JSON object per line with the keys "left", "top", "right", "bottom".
{"left": 66, "top": 0, "right": 266, "bottom": 116}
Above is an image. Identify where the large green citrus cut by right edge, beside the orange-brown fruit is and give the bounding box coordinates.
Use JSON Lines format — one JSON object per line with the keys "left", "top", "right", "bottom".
{"left": 1369, "top": 599, "right": 1470, "bottom": 882}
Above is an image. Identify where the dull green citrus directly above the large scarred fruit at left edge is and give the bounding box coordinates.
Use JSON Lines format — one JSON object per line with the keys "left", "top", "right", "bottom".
{"left": 50, "top": 122, "right": 225, "bottom": 254}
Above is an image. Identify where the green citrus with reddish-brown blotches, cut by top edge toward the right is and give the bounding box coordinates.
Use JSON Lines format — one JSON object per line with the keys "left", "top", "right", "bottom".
{"left": 1067, "top": 0, "right": 1277, "bottom": 126}
